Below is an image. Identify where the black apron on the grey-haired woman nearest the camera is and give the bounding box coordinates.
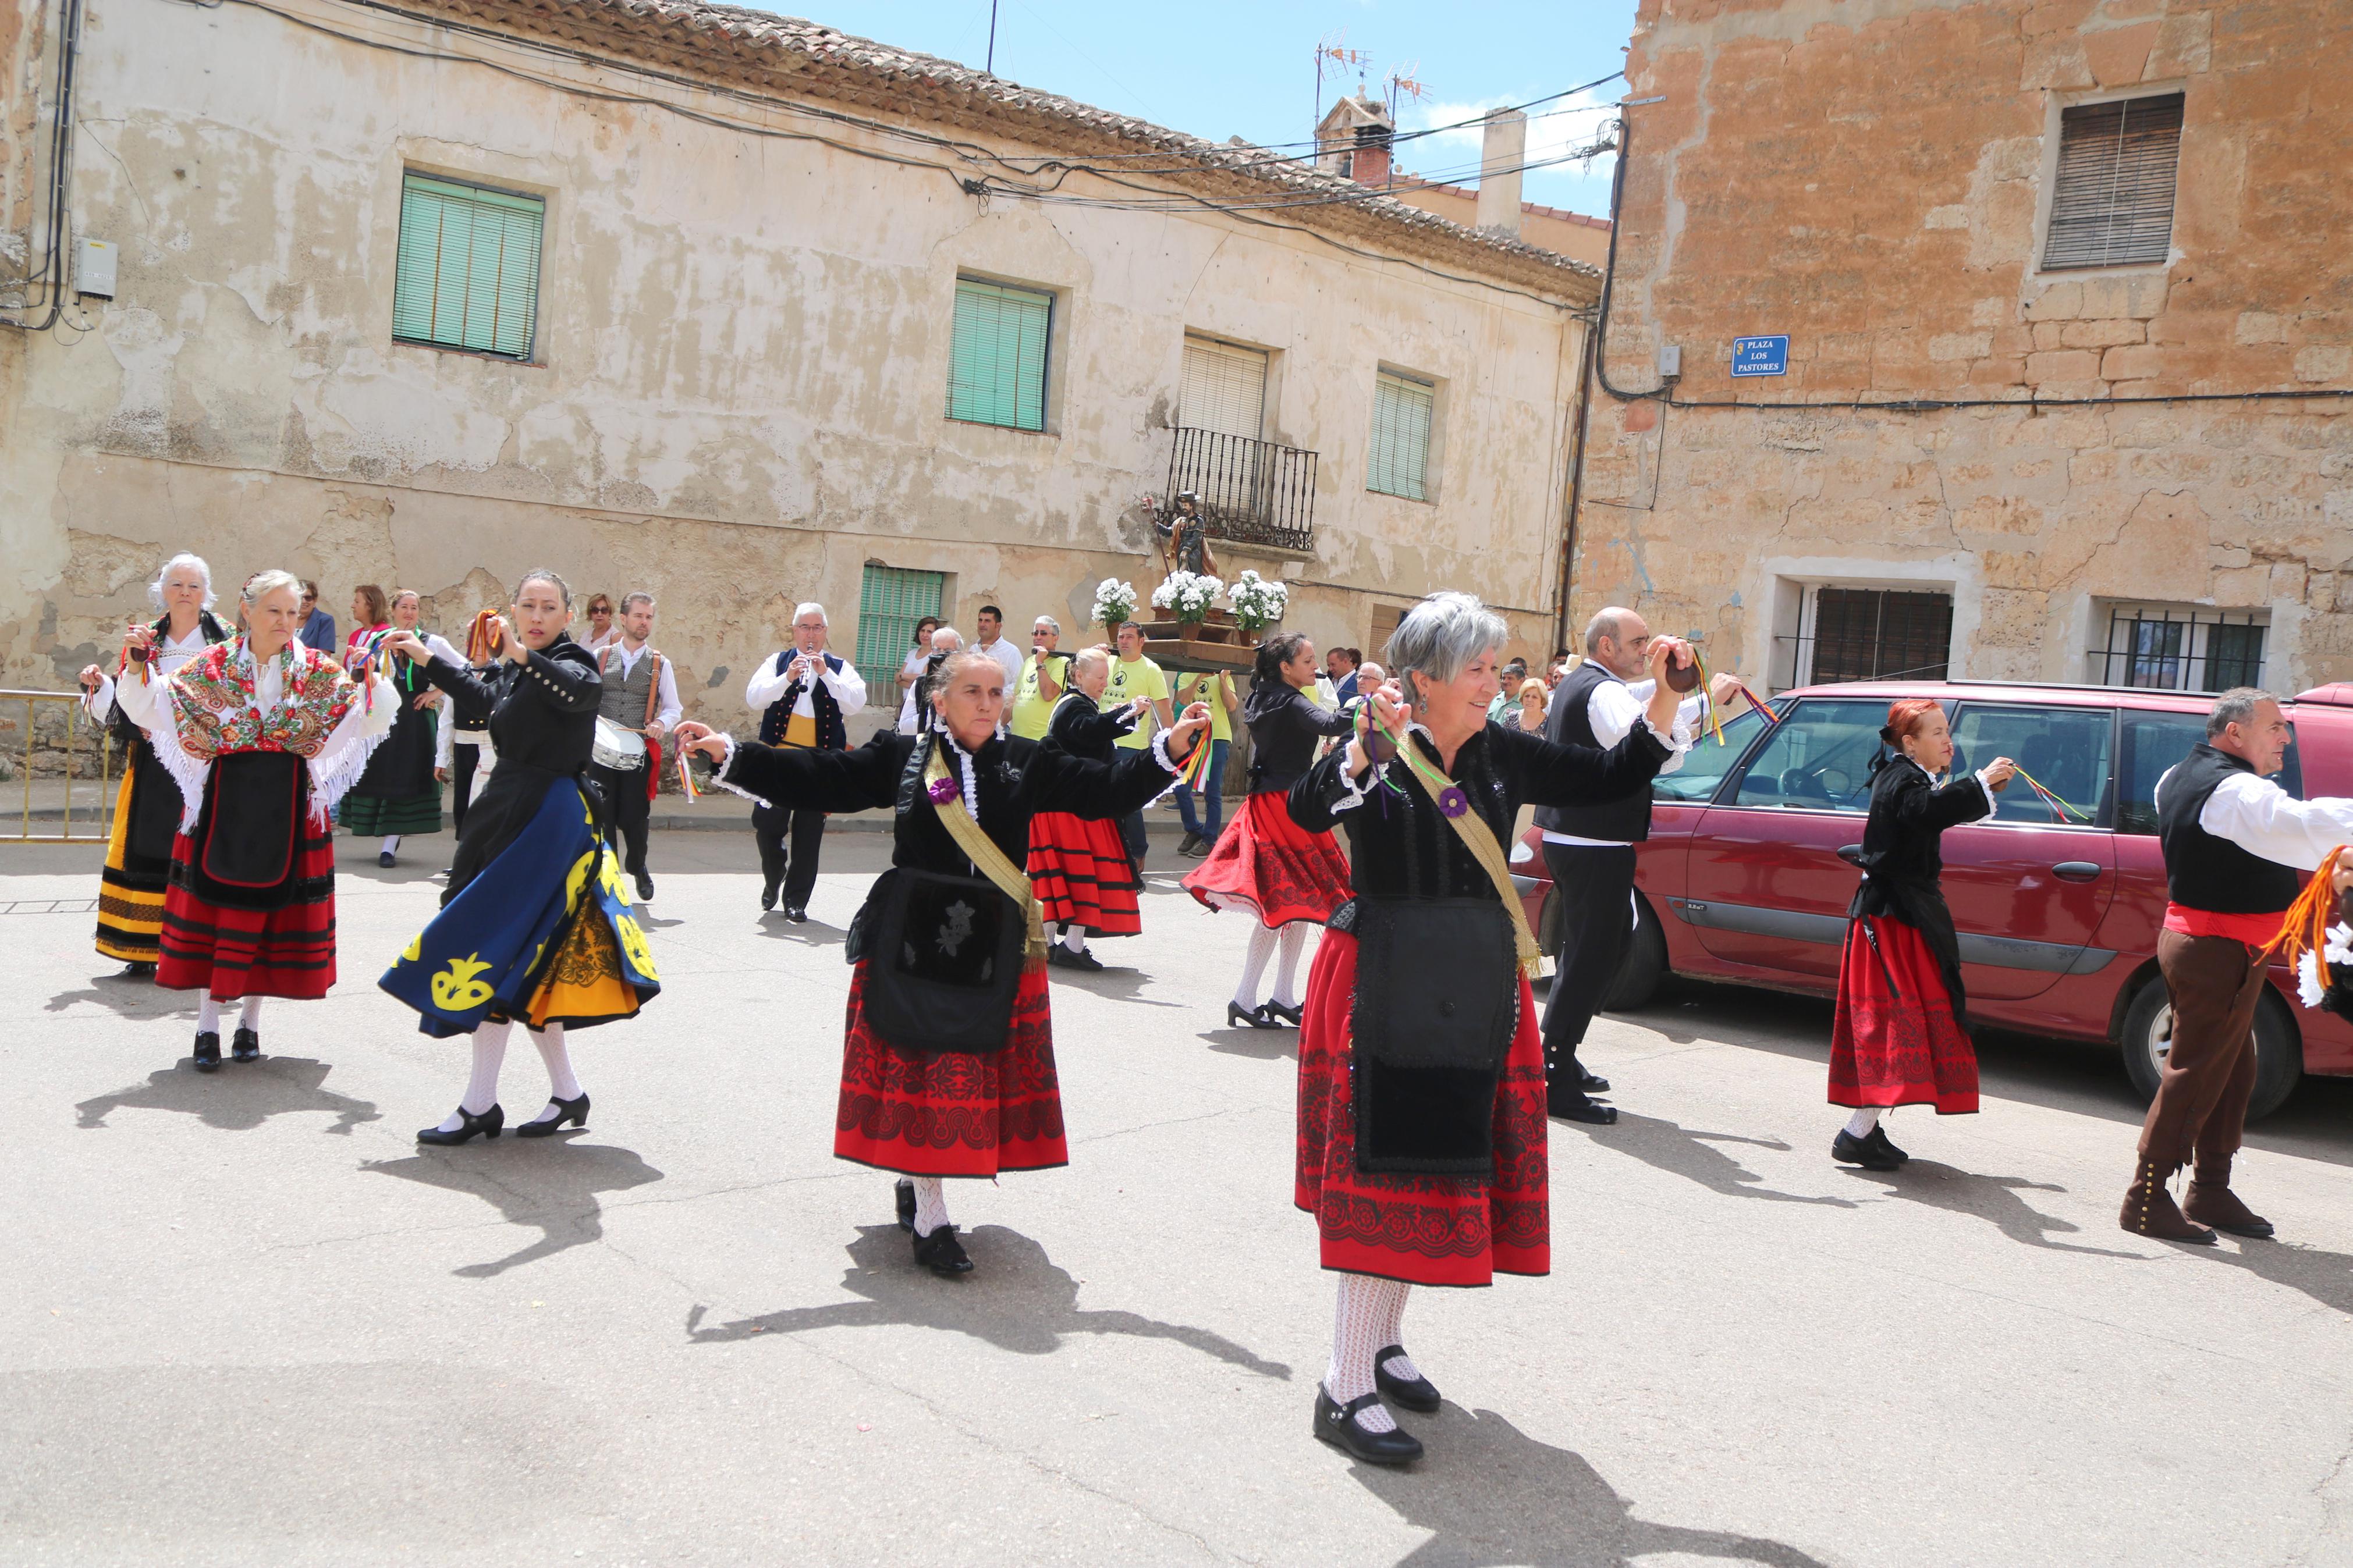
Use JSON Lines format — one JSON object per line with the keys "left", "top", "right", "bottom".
{"left": 1348, "top": 895, "right": 1520, "bottom": 1178}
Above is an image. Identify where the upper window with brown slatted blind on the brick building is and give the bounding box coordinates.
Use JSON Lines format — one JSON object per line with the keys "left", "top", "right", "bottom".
{"left": 2042, "top": 92, "right": 2181, "bottom": 273}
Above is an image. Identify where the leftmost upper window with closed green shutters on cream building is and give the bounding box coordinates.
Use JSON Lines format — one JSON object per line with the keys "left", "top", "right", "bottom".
{"left": 393, "top": 174, "right": 548, "bottom": 360}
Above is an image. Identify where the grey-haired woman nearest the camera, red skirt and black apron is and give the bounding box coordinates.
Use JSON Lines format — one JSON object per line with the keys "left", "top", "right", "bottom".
{"left": 1290, "top": 592, "right": 1692, "bottom": 1464}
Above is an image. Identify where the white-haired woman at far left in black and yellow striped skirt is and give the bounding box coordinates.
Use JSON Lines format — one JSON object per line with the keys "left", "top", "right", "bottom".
{"left": 83, "top": 555, "right": 233, "bottom": 980}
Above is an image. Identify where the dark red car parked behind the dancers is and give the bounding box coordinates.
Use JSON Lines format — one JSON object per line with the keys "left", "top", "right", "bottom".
{"left": 1511, "top": 680, "right": 2353, "bottom": 1117}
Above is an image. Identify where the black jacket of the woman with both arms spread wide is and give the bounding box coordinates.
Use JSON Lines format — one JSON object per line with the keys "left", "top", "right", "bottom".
{"left": 715, "top": 731, "right": 1169, "bottom": 901}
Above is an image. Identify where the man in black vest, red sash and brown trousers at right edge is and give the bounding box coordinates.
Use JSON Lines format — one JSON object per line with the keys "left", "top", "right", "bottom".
{"left": 2118, "top": 687, "right": 2353, "bottom": 1246}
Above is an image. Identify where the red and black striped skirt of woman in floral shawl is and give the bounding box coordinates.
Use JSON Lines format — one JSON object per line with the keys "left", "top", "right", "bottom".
{"left": 155, "top": 818, "right": 334, "bottom": 1001}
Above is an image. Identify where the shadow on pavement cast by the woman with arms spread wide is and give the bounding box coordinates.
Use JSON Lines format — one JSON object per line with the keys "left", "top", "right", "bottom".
{"left": 687, "top": 1225, "right": 1292, "bottom": 1380}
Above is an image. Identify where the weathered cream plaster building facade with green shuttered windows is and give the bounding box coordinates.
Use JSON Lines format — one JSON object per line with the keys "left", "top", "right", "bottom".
{"left": 0, "top": 0, "right": 1600, "bottom": 738}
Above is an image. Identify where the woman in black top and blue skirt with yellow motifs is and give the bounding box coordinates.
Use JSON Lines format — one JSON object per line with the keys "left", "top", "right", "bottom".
{"left": 379, "top": 571, "right": 661, "bottom": 1145}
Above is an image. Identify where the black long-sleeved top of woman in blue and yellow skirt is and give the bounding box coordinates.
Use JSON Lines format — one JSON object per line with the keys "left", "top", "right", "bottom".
{"left": 424, "top": 637, "right": 605, "bottom": 903}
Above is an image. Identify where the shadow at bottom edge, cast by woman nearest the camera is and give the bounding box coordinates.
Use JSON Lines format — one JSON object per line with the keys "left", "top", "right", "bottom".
{"left": 1351, "top": 1403, "right": 1823, "bottom": 1568}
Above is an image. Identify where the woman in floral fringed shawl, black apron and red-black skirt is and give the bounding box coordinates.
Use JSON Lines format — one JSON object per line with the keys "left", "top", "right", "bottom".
{"left": 115, "top": 571, "right": 400, "bottom": 1072}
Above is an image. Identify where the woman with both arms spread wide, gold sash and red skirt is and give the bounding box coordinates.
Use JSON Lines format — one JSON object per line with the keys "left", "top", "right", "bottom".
{"left": 677, "top": 649, "right": 1209, "bottom": 1277}
